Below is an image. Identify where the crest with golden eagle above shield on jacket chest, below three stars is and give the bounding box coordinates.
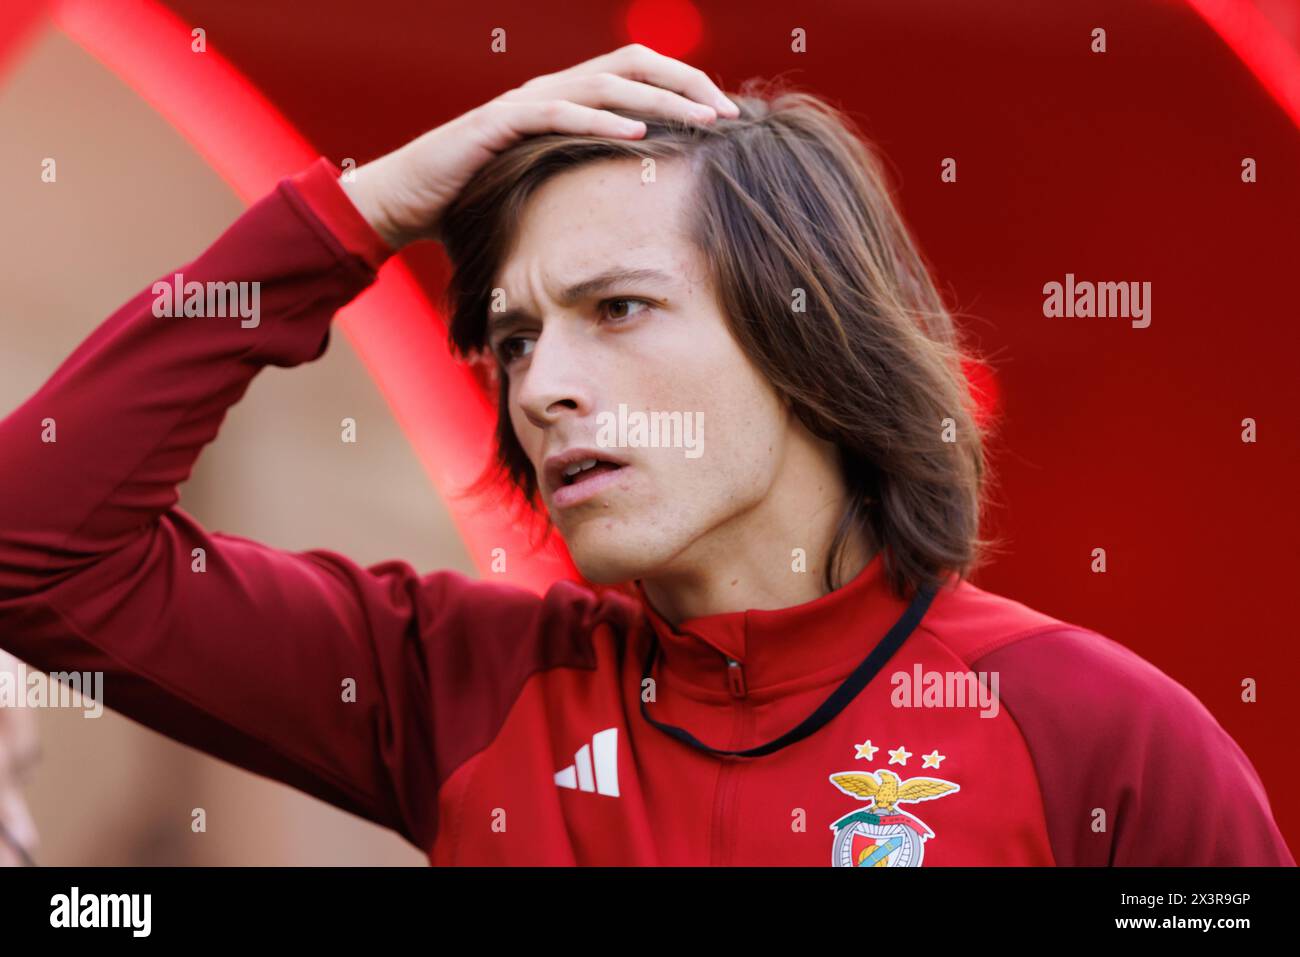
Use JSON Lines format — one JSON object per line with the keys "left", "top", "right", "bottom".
{"left": 831, "top": 768, "right": 961, "bottom": 867}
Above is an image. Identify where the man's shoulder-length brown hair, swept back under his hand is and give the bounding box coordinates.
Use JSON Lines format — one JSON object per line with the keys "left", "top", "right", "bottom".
{"left": 438, "top": 79, "right": 991, "bottom": 596}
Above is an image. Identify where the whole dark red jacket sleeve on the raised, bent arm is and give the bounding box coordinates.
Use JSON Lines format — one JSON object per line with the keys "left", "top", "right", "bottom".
{"left": 0, "top": 160, "right": 496, "bottom": 846}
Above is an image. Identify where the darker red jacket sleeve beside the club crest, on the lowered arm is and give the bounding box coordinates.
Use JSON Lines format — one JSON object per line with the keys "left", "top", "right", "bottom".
{"left": 971, "top": 627, "right": 1295, "bottom": 867}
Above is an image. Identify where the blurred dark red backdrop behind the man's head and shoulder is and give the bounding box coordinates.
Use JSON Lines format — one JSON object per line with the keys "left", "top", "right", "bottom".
{"left": 0, "top": 0, "right": 1300, "bottom": 863}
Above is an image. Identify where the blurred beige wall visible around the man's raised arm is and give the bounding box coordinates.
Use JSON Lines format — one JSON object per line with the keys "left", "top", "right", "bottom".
{"left": 0, "top": 30, "right": 473, "bottom": 865}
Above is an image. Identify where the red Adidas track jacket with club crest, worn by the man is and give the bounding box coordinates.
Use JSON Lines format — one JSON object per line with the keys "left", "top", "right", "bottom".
{"left": 0, "top": 160, "right": 1295, "bottom": 866}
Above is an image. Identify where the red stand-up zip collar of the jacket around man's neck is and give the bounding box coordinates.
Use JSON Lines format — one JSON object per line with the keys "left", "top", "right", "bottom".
{"left": 634, "top": 553, "right": 907, "bottom": 698}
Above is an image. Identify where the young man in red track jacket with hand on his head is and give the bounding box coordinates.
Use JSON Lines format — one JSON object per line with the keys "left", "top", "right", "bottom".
{"left": 0, "top": 47, "right": 1294, "bottom": 866}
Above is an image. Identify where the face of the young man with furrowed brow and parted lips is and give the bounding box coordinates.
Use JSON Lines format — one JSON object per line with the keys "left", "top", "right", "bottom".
{"left": 489, "top": 159, "right": 790, "bottom": 583}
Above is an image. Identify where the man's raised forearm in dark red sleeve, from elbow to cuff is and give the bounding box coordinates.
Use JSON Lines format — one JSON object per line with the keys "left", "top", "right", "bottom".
{"left": 0, "top": 160, "right": 373, "bottom": 596}
